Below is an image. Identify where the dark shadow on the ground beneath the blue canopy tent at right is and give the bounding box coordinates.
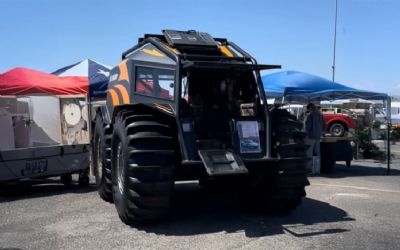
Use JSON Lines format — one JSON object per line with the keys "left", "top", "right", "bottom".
{"left": 321, "top": 162, "right": 400, "bottom": 178}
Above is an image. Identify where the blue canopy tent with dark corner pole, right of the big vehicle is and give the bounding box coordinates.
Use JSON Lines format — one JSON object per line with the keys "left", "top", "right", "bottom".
{"left": 262, "top": 71, "right": 391, "bottom": 174}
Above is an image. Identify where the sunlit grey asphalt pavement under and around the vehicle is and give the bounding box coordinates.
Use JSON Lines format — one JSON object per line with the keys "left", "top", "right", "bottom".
{"left": 0, "top": 160, "right": 400, "bottom": 249}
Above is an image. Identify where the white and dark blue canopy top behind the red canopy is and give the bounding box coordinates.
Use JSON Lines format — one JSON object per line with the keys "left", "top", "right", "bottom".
{"left": 52, "top": 59, "right": 111, "bottom": 98}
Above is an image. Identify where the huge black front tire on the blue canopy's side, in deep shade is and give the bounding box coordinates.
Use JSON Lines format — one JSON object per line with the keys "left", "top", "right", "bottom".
{"left": 241, "top": 109, "right": 309, "bottom": 213}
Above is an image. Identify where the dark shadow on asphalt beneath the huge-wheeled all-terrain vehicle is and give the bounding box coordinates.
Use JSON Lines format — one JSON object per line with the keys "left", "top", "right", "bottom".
{"left": 138, "top": 183, "right": 355, "bottom": 237}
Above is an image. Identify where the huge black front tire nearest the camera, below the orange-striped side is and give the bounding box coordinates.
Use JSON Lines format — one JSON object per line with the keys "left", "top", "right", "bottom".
{"left": 111, "top": 111, "right": 175, "bottom": 225}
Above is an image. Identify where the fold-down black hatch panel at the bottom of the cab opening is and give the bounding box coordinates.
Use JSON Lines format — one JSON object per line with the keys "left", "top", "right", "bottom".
{"left": 199, "top": 150, "right": 248, "bottom": 176}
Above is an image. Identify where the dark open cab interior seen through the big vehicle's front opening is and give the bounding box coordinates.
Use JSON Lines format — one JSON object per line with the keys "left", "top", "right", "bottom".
{"left": 181, "top": 69, "right": 263, "bottom": 149}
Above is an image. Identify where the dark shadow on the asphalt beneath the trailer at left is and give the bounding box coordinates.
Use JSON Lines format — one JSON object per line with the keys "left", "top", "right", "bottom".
{"left": 0, "top": 178, "right": 96, "bottom": 203}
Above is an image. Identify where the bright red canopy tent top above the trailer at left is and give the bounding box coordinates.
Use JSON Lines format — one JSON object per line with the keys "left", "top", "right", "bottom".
{"left": 0, "top": 67, "right": 89, "bottom": 95}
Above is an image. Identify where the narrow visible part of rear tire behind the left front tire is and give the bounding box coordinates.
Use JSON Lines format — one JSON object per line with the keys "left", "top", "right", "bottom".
{"left": 93, "top": 113, "right": 113, "bottom": 202}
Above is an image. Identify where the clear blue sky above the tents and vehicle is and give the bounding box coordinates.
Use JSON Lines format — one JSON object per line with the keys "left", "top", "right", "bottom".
{"left": 0, "top": 0, "right": 400, "bottom": 95}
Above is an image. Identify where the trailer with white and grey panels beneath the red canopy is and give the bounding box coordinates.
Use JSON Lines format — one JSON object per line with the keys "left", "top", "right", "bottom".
{"left": 0, "top": 95, "right": 89, "bottom": 185}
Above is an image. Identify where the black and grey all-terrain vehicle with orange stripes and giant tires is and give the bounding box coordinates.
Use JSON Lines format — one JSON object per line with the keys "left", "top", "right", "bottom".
{"left": 93, "top": 30, "right": 309, "bottom": 224}
